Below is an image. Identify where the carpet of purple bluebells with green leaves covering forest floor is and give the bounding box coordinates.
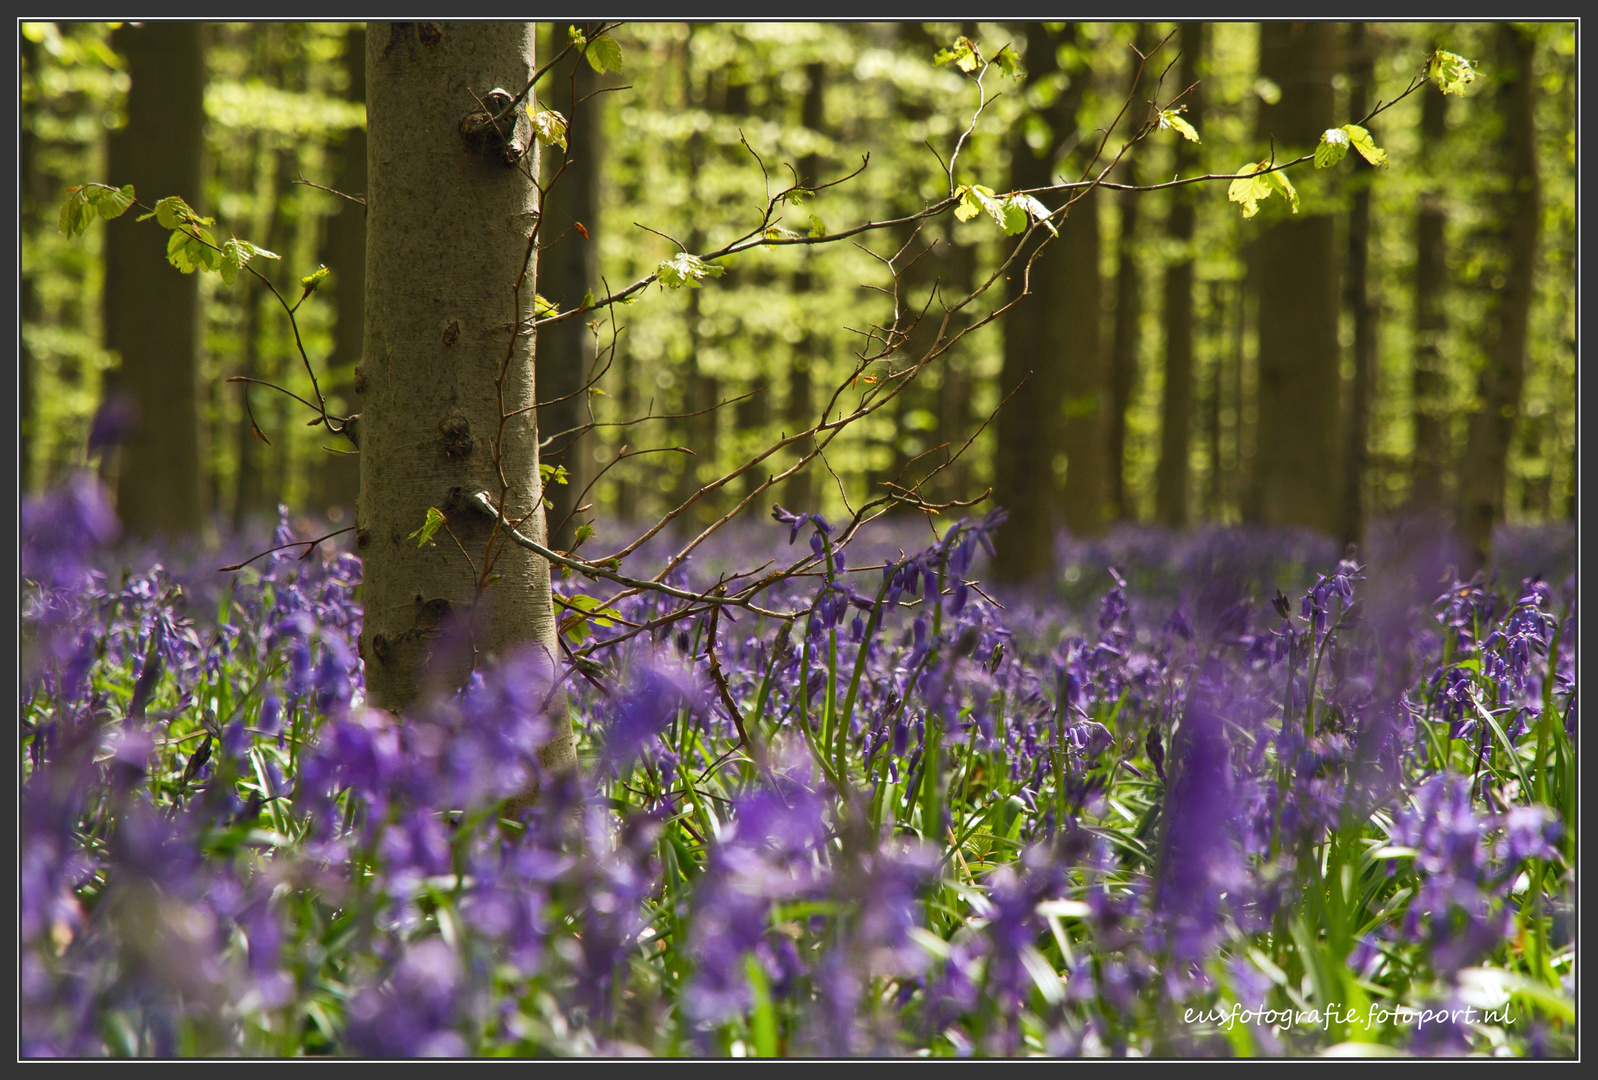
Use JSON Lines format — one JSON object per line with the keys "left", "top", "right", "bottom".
{"left": 19, "top": 478, "right": 1577, "bottom": 1058}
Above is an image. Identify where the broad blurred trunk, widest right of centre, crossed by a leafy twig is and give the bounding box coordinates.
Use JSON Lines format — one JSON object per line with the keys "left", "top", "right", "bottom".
{"left": 1253, "top": 22, "right": 1342, "bottom": 532}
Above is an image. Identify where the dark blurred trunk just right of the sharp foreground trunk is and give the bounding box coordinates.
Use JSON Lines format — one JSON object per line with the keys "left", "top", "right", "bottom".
{"left": 539, "top": 27, "right": 604, "bottom": 550}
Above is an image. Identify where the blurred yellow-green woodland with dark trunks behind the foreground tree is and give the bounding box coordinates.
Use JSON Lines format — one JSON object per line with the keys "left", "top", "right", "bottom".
{"left": 19, "top": 22, "right": 1576, "bottom": 578}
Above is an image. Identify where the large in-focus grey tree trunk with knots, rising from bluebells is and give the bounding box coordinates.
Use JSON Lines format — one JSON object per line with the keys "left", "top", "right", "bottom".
{"left": 356, "top": 22, "right": 575, "bottom": 768}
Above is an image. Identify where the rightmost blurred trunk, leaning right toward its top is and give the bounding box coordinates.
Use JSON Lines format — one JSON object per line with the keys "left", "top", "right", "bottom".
{"left": 1459, "top": 22, "right": 1542, "bottom": 574}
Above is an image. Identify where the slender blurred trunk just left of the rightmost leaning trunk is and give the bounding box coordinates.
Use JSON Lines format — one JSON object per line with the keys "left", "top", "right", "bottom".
{"left": 1409, "top": 83, "right": 1454, "bottom": 514}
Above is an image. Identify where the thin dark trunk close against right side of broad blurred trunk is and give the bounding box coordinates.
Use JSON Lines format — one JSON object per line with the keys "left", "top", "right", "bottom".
{"left": 1342, "top": 22, "right": 1377, "bottom": 543}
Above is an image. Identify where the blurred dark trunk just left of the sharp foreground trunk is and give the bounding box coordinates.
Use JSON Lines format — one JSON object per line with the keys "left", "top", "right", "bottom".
{"left": 316, "top": 24, "right": 366, "bottom": 521}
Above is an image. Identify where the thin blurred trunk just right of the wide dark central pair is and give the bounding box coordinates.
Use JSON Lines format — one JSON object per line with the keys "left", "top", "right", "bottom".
{"left": 1109, "top": 22, "right": 1157, "bottom": 518}
